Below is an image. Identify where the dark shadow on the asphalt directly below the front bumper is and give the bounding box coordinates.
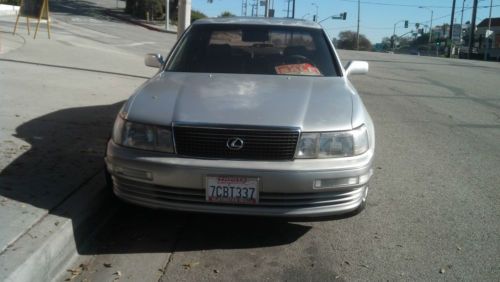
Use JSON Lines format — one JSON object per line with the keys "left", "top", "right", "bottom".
{"left": 85, "top": 204, "right": 311, "bottom": 255}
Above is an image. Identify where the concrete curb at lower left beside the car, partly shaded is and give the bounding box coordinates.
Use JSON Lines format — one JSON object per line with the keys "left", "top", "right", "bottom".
{"left": 0, "top": 171, "right": 116, "bottom": 282}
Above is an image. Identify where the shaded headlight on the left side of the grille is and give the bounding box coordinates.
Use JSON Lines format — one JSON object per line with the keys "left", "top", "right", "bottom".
{"left": 113, "top": 114, "right": 174, "bottom": 153}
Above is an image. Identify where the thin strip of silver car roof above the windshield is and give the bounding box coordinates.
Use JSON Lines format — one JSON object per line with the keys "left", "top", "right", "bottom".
{"left": 189, "top": 17, "right": 322, "bottom": 29}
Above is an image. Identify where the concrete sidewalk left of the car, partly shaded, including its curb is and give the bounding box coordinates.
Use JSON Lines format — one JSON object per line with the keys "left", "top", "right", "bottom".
{"left": 0, "top": 12, "right": 156, "bottom": 281}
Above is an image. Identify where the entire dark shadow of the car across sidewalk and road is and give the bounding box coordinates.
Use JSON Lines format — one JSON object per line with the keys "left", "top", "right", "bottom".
{"left": 0, "top": 102, "right": 311, "bottom": 254}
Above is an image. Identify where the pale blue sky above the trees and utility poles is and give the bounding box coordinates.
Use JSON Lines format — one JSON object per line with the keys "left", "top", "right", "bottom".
{"left": 192, "top": 0, "right": 500, "bottom": 43}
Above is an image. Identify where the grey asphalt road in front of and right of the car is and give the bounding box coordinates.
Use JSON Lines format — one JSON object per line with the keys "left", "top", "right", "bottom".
{"left": 65, "top": 52, "right": 500, "bottom": 281}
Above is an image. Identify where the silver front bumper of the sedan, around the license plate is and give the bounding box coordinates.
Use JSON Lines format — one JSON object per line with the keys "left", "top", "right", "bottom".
{"left": 105, "top": 140, "right": 373, "bottom": 216}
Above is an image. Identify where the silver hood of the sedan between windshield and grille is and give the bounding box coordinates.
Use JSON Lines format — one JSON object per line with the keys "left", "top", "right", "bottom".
{"left": 124, "top": 72, "right": 356, "bottom": 131}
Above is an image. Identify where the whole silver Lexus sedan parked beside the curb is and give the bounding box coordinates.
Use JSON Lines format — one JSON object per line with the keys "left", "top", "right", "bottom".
{"left": 105, "top": 18, "right": 375, "bottom": 216}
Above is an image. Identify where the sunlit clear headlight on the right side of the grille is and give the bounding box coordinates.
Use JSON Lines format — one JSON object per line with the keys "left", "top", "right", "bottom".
{"left": 295, "top": 125, "right": 369, "bottom": 159}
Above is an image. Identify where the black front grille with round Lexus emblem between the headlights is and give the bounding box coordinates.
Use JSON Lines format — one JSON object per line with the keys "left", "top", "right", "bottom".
{"left": 174, "top": 125, "right": 299, "bottom": 161}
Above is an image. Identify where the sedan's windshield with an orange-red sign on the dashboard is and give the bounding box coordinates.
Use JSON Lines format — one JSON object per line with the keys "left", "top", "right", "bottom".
{"left": 167, "top": 25, "right": 337, "bottom": 76}
